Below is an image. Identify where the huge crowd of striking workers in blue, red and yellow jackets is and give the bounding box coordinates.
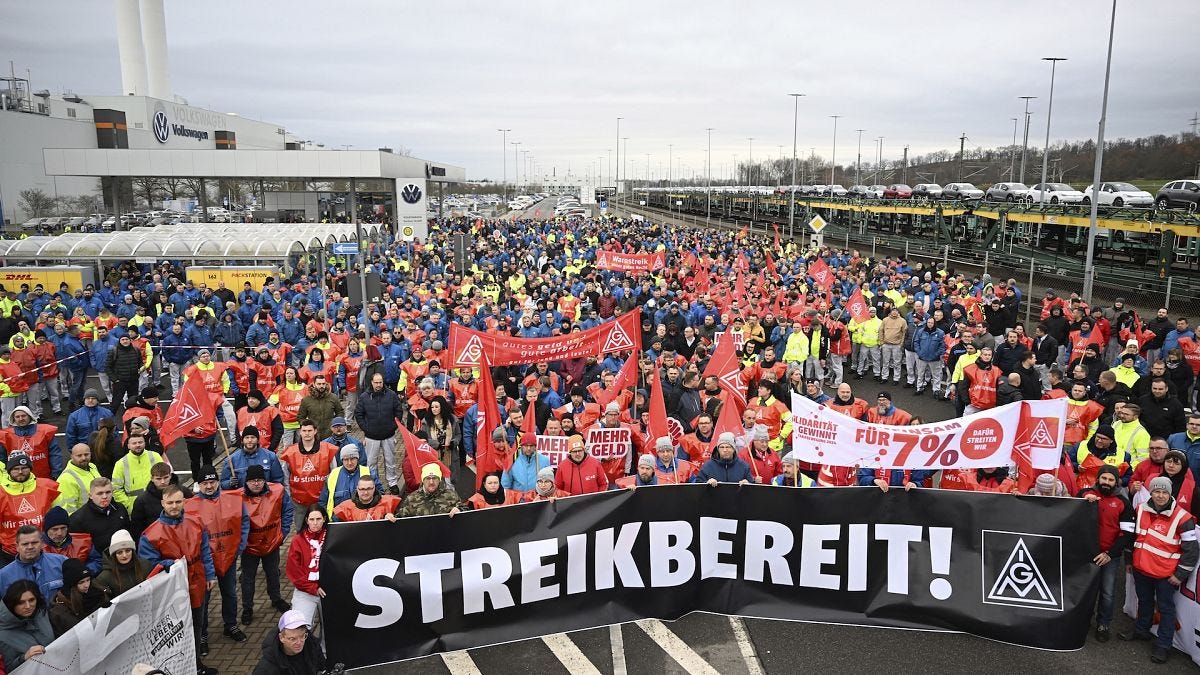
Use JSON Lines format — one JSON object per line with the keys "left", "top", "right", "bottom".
{"left": 0, "top": 211, "right": 1200, "bottom": 673}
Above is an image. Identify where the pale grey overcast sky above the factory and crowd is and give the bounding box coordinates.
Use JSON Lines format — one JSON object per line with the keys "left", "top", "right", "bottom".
{"left": 0, "top": 0, "right": 1200, "bottom": 180}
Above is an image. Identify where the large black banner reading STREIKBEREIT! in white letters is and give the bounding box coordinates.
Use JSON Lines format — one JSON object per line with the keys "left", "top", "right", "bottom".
{"left": 320, "top": 485, "right": 1098, "bottom": 667}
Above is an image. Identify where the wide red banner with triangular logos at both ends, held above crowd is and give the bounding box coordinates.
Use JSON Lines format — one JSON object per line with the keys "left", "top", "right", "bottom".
{"left": 443, "top": 310, "right": 642, "bottom": 368}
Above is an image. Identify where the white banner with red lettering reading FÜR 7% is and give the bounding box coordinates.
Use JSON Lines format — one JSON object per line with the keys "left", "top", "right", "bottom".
{"left": 792, "top": 394, "right": 1067, "bottom": 470}
